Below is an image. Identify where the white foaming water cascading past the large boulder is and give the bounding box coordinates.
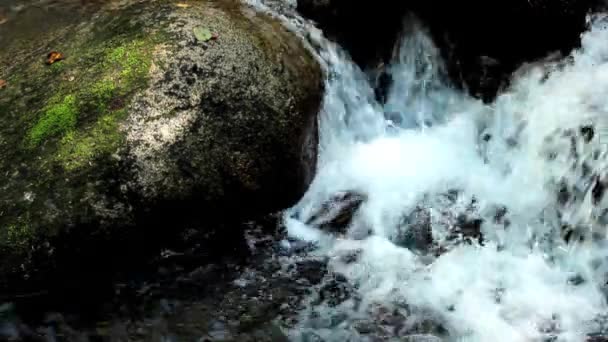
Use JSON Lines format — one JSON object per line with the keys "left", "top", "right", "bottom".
{"left": 249, "top": 2, "right": 608, "bottom": 341}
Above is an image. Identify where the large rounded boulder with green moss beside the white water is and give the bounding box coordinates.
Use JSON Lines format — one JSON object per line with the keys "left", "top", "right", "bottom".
{"left": 0, "top": 0, "right": 322, "bottom": 293}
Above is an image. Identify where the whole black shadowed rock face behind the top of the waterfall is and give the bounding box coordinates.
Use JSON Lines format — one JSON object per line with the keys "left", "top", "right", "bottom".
{"left": 298, "top": 0, "right": 602, "bottom": 101}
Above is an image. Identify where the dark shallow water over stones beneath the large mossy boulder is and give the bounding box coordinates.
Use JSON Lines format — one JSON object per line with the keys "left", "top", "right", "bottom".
{"left": 0, "top": 220, "right": 318, "bottom": 342}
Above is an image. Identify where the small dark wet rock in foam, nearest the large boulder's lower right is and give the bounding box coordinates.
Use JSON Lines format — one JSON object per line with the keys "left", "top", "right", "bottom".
{"left": 306, "top": 192, "right": 367, "bottom": 234}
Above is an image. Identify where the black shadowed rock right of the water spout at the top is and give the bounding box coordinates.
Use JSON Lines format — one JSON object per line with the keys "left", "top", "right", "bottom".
{"left": 419, "top": 0, "right": 600, "bottom": 100}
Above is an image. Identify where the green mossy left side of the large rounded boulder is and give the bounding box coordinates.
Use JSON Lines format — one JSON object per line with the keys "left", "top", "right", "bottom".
{"left": 0, "top": 0, "right": 178, "bottom": 288}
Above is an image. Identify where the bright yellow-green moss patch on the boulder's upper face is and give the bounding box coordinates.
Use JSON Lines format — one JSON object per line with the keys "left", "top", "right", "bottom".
{"left": 26, "top": 37, "right": 156, "bottom": 170}
